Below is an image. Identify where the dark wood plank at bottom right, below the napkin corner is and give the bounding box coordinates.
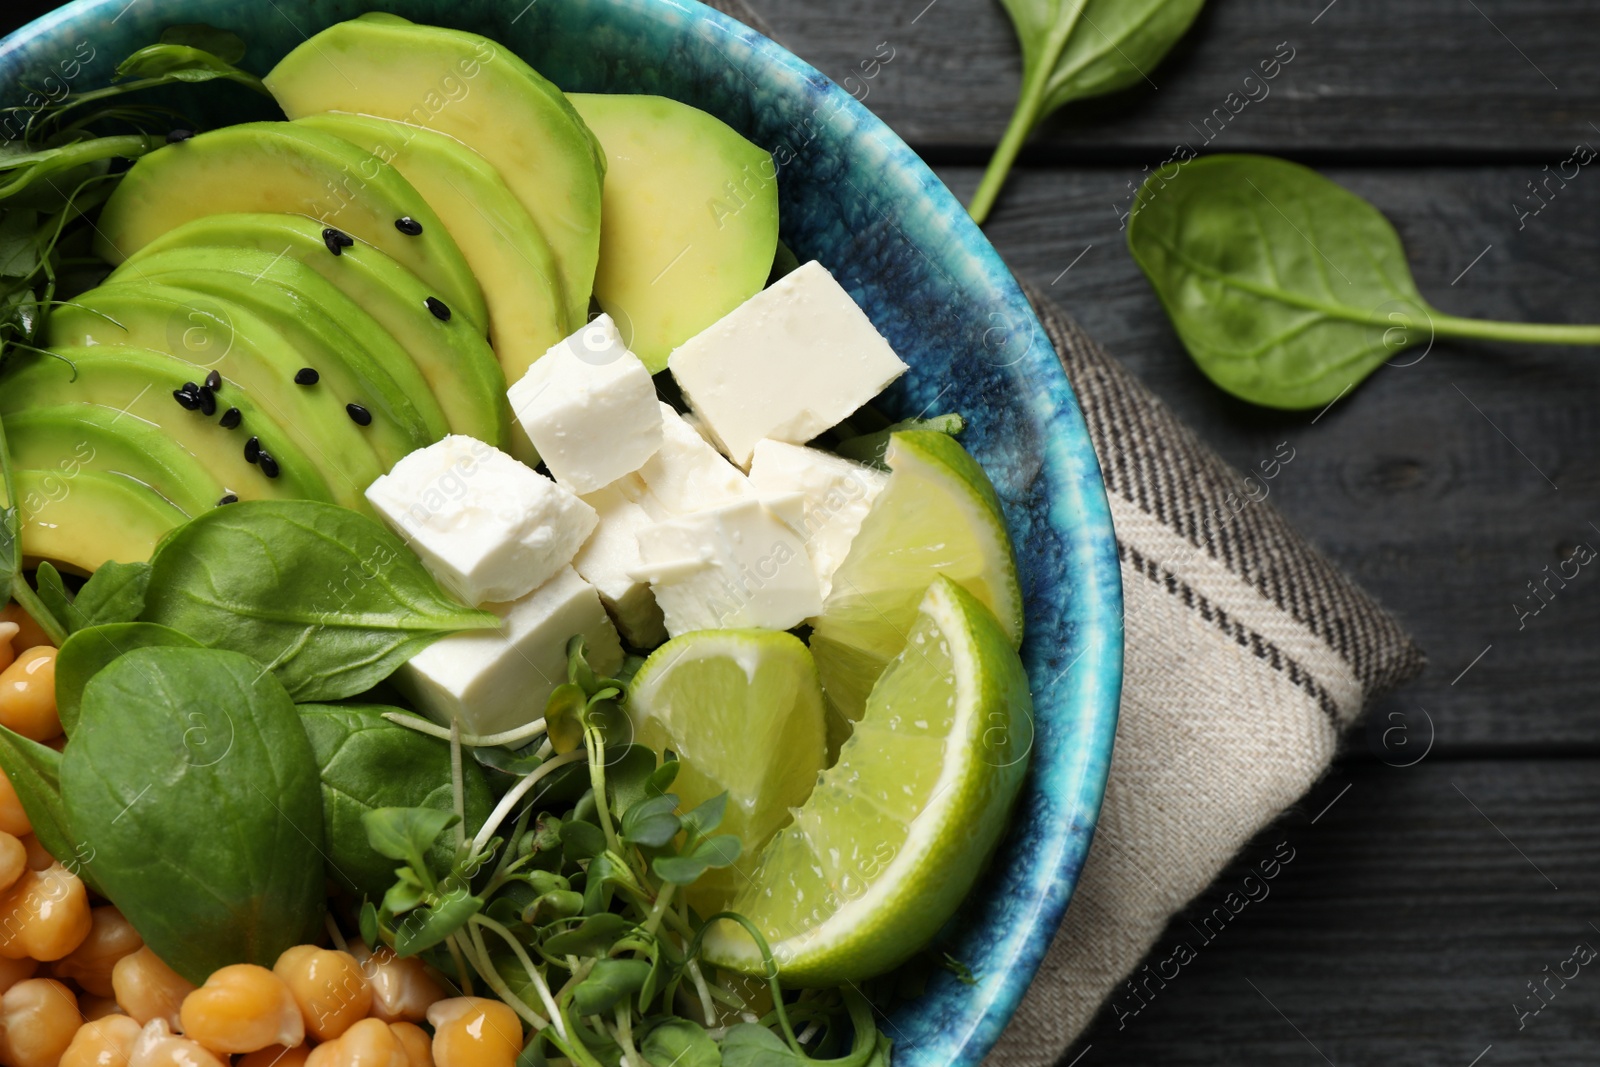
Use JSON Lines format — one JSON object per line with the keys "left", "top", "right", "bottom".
{"left": 1062, "top": 760, "right": 1600, "bottom": 1067}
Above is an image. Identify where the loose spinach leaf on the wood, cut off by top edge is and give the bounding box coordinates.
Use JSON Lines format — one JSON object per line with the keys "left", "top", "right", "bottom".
{"left": 968, "top": 0, "right": 1205, "bottom": 222}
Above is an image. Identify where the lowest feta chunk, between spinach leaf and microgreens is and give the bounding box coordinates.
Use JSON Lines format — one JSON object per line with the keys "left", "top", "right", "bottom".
{"left": 394, "top": 566, "right": 622, "bottom": 734}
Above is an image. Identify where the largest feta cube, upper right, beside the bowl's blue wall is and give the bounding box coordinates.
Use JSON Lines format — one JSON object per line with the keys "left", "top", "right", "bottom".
{"left": 667, "top": 259, "right": 906, "bottom": 467}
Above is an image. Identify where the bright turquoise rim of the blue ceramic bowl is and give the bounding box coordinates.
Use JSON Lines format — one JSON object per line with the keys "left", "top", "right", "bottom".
{"left": 0, "top": 0, "right": 1123, "bottom": 1067}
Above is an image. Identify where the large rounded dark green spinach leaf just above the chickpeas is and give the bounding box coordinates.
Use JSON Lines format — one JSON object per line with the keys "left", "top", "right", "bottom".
{"left": 61, "top": 643, "right": 323, "bottom": 984}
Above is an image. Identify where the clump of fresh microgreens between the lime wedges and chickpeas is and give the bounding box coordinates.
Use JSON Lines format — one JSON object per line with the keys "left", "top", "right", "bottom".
{"left": 360, "top": 637, "right": 888, "bottom": 1067}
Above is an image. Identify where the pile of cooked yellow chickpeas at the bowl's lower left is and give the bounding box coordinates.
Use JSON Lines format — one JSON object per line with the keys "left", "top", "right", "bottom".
{"left": 0, "top": 603, "right": 523, "bottom": 1067}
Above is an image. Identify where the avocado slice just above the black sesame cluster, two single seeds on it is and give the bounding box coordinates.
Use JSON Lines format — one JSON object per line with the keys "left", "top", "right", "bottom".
{"left": 48, "top": 282, "right": 387, "bottom": 514}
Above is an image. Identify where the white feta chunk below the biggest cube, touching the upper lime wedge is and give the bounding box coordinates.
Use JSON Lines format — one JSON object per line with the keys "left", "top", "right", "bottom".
{"left": 750, "top": 442, "right": 890, "bottom": 598}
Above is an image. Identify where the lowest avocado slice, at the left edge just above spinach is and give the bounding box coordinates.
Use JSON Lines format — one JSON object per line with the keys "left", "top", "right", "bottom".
{"left": 14, "top": 470, "right": 184, "bottom": 574}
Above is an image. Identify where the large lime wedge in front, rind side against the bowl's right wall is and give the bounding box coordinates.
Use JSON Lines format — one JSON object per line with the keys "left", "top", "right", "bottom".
{"left": 706, "top": 577, "right": 1034, "bottom": 985}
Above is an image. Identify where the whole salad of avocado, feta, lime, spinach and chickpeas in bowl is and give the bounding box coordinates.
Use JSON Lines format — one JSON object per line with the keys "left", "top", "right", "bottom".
{"left": 0, "top": 11, "right": 1115, "bottom": 1067}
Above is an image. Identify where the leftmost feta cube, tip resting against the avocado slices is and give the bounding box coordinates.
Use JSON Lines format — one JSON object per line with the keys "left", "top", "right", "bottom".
{"left": 366, "top": 435, "right": 598, "bottom": 605}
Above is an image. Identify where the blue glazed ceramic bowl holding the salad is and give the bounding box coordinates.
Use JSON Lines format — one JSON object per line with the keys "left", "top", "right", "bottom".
{"left": 0, "top": 8, "right": 1122, "bottom": 1067}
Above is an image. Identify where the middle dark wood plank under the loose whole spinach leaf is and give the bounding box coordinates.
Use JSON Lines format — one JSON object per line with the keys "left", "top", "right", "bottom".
{"left": 941, "top": 166, "right": 1600, "bottom": 745}
